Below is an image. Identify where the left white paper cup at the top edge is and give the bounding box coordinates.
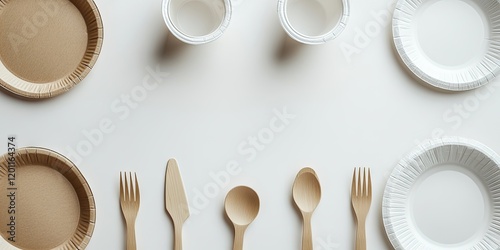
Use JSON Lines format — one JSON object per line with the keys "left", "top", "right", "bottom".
{"left": 162, "top": 0, "right": 232, "bottom": 45}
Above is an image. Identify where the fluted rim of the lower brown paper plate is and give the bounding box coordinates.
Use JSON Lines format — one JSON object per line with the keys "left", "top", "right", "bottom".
{"left": 0, "top": 147, "right": 96, "bottom": 250}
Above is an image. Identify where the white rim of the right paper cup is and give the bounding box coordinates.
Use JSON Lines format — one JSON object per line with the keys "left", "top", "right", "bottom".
{"left": 278, "top": 0, "right": 350, "bottom": 45}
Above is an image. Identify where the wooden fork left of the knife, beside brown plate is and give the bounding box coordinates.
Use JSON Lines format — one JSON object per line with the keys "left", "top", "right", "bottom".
{"left": 120, "top": 172, "right": 141, "bottom": 250}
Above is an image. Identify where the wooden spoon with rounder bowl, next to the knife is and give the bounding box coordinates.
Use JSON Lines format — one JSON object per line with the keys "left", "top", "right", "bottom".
{"left": 224, "top": 186, "right": 260, "bottom": 250}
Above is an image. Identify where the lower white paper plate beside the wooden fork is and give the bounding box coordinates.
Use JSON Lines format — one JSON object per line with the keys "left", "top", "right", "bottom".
{"left": 382, "top": 138, "right": 500, "bottom": 250}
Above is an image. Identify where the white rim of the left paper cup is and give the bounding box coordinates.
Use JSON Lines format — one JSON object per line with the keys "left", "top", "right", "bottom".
{"left": 162, "top": 0, "right": 233, "bottom": 45}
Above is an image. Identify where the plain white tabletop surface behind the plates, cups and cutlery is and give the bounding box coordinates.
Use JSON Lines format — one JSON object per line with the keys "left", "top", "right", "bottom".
{"left": 0, "top": 0, "right": 500, "bottom": 250}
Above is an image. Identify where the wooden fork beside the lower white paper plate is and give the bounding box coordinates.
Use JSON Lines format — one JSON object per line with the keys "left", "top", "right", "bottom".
{"left": 351, "top": 168, "right": 372, "bottom": 250}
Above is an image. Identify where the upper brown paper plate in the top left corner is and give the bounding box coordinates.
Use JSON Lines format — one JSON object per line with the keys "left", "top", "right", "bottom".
{"left": 0, "top": 0, "right": 103, "bottom": 99}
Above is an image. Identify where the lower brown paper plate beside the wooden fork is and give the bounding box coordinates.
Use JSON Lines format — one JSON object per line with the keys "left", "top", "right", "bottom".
{"left": 0, "top": 147, "right": 96, "bottom": 250}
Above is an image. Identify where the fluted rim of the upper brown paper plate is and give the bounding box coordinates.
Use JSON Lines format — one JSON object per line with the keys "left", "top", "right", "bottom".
{"left": 0, "top": 0, "right": 104, "bottom": 99}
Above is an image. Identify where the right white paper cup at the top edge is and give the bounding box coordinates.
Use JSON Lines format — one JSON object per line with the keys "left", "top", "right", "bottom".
{"left": 278, "top": 0, "right": 350, "bottom": 44}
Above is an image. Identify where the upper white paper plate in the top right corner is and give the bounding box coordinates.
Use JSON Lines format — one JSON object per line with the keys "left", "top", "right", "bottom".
{"left": 392, "top": 0, "right": 500, "bottom": 91}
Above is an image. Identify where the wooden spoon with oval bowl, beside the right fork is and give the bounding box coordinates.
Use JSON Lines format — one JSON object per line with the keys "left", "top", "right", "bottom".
{"left": 292, "top": 167, "right": 321, "bottom": 250}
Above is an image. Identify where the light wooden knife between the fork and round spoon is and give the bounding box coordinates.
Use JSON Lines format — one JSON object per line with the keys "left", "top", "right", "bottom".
{"left": 165, "top": 159, "right": 189, "bottom": 250}
